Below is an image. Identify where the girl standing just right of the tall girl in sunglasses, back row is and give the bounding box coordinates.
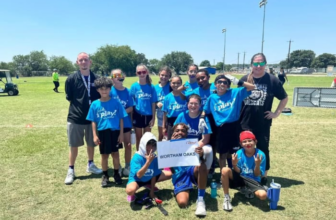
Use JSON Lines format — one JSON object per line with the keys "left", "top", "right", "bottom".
{"left": 155, "top": 66, "right": 171, "bottom": 141}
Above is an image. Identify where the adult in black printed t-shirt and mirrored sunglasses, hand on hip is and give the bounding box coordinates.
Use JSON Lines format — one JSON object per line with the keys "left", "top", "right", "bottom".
{"left": 240, "top": 53, "right": 288, "bottom": 179}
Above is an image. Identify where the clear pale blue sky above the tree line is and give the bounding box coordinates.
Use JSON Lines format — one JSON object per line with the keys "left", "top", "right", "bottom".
{"left": 0, "top": 0, "right": 336, "bottom": 64}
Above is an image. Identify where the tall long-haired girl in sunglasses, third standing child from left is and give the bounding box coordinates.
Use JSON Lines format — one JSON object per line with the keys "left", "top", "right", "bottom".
{"left": 130, "top": 64, "right": 157, "bottom": 150}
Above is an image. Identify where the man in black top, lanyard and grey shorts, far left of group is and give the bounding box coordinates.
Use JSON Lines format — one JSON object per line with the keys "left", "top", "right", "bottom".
{"left": 64, "top": 52, "right": 102, "bottom": 185}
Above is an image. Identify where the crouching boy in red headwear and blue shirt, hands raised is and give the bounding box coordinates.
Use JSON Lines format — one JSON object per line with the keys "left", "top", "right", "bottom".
{"left": 221, "top": 131, "right": 267, "bottom": 211}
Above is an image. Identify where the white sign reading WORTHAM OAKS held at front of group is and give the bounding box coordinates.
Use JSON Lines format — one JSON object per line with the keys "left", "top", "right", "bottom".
{"left": 157, "top": 138, "right": 200, "bottom": 169}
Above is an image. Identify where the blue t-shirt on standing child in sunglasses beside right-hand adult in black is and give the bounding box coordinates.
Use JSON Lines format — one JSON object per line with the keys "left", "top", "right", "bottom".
{"left": 203, "top": 87, "right": 251, "bottom": 126}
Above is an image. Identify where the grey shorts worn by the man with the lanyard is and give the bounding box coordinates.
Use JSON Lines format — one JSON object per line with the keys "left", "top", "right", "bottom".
{"left": 67, "top": 122, "right": 96, "bottom": 147}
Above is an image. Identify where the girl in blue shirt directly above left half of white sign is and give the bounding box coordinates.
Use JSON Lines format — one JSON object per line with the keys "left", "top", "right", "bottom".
{"left": 162, "top": 76, "right": 186, "bottom": 140}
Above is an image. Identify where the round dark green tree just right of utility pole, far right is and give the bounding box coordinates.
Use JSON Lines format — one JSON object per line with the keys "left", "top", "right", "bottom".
{"left": 289, "top": 50, "right": 315, "bottom": 68}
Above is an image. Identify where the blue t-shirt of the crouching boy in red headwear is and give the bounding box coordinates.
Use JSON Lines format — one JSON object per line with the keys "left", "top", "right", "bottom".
{"left": 237, "top": 148, "right": 266, "bottom": 183}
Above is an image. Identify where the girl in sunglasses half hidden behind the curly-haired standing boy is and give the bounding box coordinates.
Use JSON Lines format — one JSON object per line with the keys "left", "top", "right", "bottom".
{"left": 110, "top": 69, "right": 134, "bottom": 176}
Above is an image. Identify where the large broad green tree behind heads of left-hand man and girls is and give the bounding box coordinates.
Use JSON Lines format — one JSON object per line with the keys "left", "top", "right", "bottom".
{"left": 91, "top": 45, "right": 138, "bottom": 76}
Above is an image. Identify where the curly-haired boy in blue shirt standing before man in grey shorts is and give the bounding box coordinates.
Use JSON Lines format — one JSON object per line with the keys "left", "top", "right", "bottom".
{"left": 86, "top": 77, "right": 128, "bottom": 187}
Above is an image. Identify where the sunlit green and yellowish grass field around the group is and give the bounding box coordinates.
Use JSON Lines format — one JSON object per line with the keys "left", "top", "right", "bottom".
{"left": 0, "top": 76, "right": 336, "bottom": 219}
